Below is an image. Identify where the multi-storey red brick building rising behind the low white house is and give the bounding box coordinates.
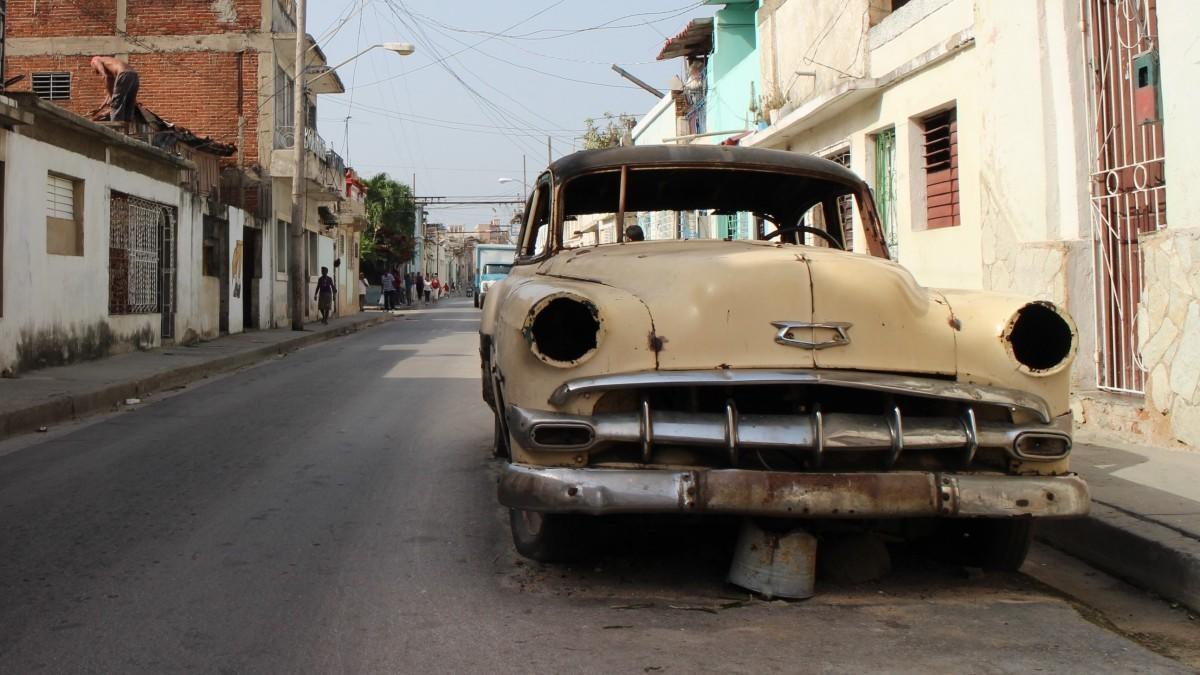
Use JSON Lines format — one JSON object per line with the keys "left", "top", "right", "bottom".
{"left": 4, "top": 0, "right": 366, "bottom": 327}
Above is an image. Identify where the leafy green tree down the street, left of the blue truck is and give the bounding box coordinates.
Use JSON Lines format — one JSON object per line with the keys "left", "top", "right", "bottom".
{"left": 362, "top": 173, "right": 416, "bottom": 276}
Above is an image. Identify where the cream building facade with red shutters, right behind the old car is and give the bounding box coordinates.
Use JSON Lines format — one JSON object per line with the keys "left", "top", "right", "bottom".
{"left": 635, "top": 0, "right": 1200, "bottom": 447}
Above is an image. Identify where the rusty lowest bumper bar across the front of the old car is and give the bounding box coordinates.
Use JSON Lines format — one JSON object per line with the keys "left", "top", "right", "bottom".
{"left": 499, "top": 464, "right": 1091, "bottom": 519}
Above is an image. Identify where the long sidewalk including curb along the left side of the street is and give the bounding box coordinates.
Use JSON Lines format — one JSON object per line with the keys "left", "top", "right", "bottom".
{"left": 0, "top": 312, "right": 392, "bottom": 438}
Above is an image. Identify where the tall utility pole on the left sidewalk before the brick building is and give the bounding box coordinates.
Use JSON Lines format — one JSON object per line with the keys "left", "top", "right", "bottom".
{"left": 288, "top": 0, "right": 308, "bottom": 330}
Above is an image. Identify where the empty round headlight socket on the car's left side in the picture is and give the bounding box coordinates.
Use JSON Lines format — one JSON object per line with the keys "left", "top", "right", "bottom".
{"left": 523, "top": 293, "right": 604, "bottom": 368}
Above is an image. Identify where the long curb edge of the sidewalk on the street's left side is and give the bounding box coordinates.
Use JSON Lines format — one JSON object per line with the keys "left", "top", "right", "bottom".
{"left": 0, "top": 315, "right": 394, "bottom": 441}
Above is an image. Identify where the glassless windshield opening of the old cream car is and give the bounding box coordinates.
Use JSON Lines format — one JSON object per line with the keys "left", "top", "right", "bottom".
{"left": 562, "top": 167, "right": 854, "bottom": 249}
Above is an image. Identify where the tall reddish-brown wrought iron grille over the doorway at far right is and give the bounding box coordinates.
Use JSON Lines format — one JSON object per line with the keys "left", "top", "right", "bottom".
{"left": 1080, "top": 0, "right": 1166, "bottom": 394}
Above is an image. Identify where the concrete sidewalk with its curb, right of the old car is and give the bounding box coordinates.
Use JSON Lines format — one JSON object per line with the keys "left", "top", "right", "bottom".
{"left": 1037, "top": 436, "right": 1200, "bottom": 611}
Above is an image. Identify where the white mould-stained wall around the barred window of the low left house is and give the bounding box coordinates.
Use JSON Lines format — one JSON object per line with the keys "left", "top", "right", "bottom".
{"left": 0, "top": 126, "right": 180, "bottom": 370}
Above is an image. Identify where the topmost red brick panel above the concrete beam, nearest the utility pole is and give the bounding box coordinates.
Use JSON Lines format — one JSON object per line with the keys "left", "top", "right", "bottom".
{"left": 126, "top": 0, "right": 263, "bottom": 35}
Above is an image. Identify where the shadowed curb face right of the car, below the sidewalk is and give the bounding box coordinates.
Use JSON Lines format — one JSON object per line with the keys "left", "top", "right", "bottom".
{"left": 1034, "top": 501, "right": 1200, "bottom": 611}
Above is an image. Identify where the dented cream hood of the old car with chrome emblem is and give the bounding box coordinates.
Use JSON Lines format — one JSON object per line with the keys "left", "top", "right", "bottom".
{"left": 538, "top": 240, "right": 955, "bottom": 375}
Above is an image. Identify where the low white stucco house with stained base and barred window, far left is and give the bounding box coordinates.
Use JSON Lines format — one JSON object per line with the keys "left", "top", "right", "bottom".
{"left": 0, "top": 94, "right": 255, "bottom": 372}
